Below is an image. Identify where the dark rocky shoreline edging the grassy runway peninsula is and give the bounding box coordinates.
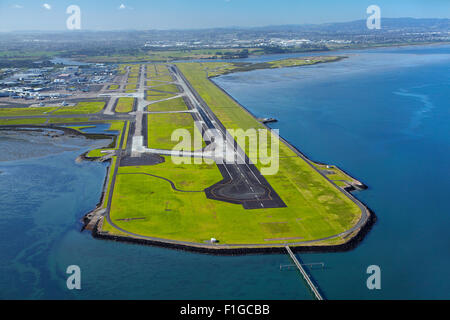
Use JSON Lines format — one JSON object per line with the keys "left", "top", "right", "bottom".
{"left": 3, "top": 67, "right": 376, "bottom": 254}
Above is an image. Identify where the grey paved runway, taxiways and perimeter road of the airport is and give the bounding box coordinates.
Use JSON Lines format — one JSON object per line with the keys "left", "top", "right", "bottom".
{"left": 0, "top": 62, "right": 370, "bottom": 248}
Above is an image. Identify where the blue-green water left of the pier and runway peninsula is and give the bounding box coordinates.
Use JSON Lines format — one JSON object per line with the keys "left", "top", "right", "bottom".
{"left": 0, "top": 125, "right": 311, "bottom": 299}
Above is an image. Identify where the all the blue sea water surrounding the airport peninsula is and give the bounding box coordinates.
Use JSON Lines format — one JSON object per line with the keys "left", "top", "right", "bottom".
{"left": 0, "top": 46, "right": 450, "bottom": 299}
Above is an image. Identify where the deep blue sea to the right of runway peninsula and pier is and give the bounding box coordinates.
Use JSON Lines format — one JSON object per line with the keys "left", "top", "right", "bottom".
{"left": 215, "top": 46, "right": 450, "bottom": 299}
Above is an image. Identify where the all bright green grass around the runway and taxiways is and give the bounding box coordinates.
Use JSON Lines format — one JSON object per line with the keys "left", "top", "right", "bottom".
{"left": 0, "top": 61, "right": 361, "bottom": 245}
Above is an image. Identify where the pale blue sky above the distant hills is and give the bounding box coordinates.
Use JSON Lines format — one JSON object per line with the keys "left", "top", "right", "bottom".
{"left": 0, "top": 0, "right": 450, "bottom": 31}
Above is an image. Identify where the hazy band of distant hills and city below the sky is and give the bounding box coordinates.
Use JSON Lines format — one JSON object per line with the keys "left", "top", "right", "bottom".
{"left": 0, "top": 18, "right": 450, "bottom": 59}
